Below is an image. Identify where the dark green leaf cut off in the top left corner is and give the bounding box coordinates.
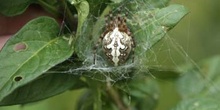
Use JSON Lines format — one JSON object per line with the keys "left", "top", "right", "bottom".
{"left": 0, "top": 0, "right": 34, "bottom": 16}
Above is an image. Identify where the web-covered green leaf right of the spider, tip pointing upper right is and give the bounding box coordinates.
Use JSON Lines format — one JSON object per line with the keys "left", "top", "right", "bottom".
{"left": 129, "top": 5, "right": 188, "bottom": 62}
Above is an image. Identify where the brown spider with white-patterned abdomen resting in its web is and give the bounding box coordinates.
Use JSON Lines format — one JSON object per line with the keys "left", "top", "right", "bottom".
{"left": 94, "top": 9, "right": 135, "bottom": 66}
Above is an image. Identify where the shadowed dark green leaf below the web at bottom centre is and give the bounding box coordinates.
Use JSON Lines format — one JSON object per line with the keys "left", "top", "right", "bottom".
{"left": 105, "top": 76, "right": 159, "bottom": 110}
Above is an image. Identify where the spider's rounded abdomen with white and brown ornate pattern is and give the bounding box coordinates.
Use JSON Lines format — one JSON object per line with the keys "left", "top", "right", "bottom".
{"left": 102, "top": 27, "right": 133, "bottom": 66}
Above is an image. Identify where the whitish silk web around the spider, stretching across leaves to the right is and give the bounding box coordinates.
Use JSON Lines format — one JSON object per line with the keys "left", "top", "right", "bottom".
{"left": 53, "top": 0, "right": 217, "bottom": 95}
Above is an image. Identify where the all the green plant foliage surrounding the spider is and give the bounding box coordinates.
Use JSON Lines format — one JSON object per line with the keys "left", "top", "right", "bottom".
{"left": 3, "top": 0, "right": 219, "bottom": 110}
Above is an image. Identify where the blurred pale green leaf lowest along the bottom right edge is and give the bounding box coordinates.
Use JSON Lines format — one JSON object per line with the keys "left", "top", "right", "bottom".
{"left": 171, "top": 97, "right": 220, "bottom": 110}
